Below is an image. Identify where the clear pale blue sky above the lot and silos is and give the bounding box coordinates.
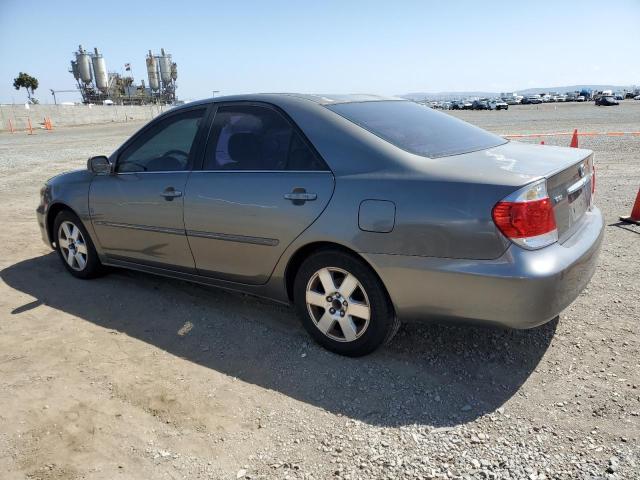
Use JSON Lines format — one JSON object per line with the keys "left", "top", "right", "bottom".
{"left": 0, "top": 0, "right": 640, "bottom": 103}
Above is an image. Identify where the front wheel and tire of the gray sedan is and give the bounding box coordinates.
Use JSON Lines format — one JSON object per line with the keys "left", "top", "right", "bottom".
{"left": 53, "top": 210, "right": 104, "bottom": 279}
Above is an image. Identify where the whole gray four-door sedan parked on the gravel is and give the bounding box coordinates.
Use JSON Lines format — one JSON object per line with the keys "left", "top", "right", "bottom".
{"left": 37, "top": 94, "right": 603, "bottom": 356}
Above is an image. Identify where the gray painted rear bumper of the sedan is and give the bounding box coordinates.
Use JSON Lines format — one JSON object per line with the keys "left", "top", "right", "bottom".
{"left": 364, "top": 208, "right": 604, "bottom": 328}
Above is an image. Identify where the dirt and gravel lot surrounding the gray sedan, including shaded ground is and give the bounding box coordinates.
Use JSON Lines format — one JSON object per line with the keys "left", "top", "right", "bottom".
{"left": 0, "top": 101, "right": 640, "bottom": 480}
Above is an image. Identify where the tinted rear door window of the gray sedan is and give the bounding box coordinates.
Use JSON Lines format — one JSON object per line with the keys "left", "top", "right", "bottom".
{"left": 204, "top": 105, "right": 327, "bottom": 171}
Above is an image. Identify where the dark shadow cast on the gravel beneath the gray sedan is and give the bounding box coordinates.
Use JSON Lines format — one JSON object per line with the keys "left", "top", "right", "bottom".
{"left": 0, "top": 253, "right": 557, "bottom": 427}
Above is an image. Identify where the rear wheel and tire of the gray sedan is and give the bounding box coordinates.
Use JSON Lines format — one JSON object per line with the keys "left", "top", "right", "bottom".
{"left": 294, "top": 250, "right": 400, "bottom": 357}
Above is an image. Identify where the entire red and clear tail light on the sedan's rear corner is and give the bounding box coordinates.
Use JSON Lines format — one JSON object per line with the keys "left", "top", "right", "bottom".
{"left": 491, "top": 180, "right": 558, "bottom": 250}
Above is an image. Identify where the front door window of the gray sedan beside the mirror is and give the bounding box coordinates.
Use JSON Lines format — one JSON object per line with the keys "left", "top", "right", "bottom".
{"left": 116, "top": 108, "right": 206, "bottom": 173}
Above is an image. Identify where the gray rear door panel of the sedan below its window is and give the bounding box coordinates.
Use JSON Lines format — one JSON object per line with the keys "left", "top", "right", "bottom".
{"left": 184, "top": 171, "right": 334, "bottom": 284}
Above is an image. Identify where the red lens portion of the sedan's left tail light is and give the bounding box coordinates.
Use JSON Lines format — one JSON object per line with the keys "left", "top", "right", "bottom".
{"left": 493, "top": 198, "right": 556, "bottom": 238}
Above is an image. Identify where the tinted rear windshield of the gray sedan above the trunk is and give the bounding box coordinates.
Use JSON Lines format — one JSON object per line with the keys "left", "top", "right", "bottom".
{"left": 327, "top": 100, "right": 507, "bottom": 158}
